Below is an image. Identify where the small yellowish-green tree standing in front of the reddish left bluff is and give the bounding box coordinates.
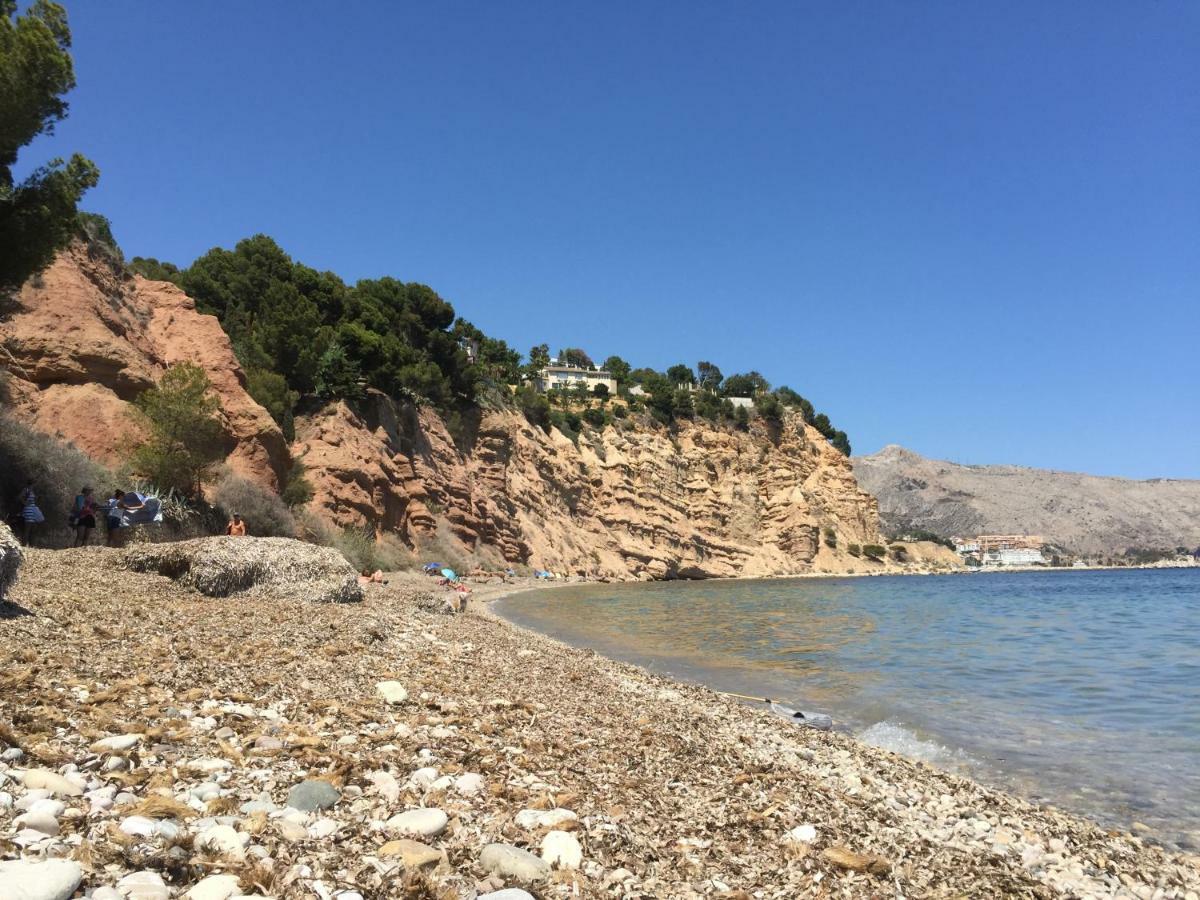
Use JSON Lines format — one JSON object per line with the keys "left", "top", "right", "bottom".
{"left": 131, "top": 362, "right": 224, "bottom": 497}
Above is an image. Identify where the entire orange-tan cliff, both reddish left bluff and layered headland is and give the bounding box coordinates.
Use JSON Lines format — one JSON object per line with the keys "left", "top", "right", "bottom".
{"left": 0, "top": 244, "right": 926, "bottom": 578}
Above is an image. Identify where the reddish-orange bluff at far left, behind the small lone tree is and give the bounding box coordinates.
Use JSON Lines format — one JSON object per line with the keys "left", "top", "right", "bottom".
{"left": 0, "top": 242, "right": 288, "bottom": 488}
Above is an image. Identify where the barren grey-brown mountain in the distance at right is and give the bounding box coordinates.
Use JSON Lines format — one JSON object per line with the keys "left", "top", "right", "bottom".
{"left": 854, "top": 444, "right": 1200, "bottom": 554}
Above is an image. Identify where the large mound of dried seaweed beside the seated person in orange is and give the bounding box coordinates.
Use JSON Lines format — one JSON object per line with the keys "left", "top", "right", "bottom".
{"left": 120, "top": 538, "right": 362, "bottom": 604}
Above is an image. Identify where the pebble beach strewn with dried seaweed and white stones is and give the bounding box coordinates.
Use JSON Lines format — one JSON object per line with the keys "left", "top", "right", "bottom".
{"left": 0, "top": 548, "right": 1200, "bottom": 900}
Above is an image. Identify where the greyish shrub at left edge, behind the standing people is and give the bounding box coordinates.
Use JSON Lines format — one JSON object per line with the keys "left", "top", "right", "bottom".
{"left": 0, "top": 415, "right": 119, "bottom": 546}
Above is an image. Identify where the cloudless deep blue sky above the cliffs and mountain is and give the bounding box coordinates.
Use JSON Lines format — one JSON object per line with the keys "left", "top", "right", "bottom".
{"left": 23, "top": 0, "right": 1200, "bottom": 478}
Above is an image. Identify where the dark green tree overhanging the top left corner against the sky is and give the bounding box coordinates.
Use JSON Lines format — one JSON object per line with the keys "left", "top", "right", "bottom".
{"left": 0, "top": 0, "right": 100, "bottom": 299}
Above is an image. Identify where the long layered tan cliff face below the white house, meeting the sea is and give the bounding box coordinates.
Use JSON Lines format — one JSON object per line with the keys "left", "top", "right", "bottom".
{"left": 293, "top": 395, "right": 880, "bottom": 578}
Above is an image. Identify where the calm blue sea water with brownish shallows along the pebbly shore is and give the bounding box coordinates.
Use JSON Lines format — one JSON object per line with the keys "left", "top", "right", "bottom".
{"left": 498, "top": 569, "right": 1200, "bottom": 848}
